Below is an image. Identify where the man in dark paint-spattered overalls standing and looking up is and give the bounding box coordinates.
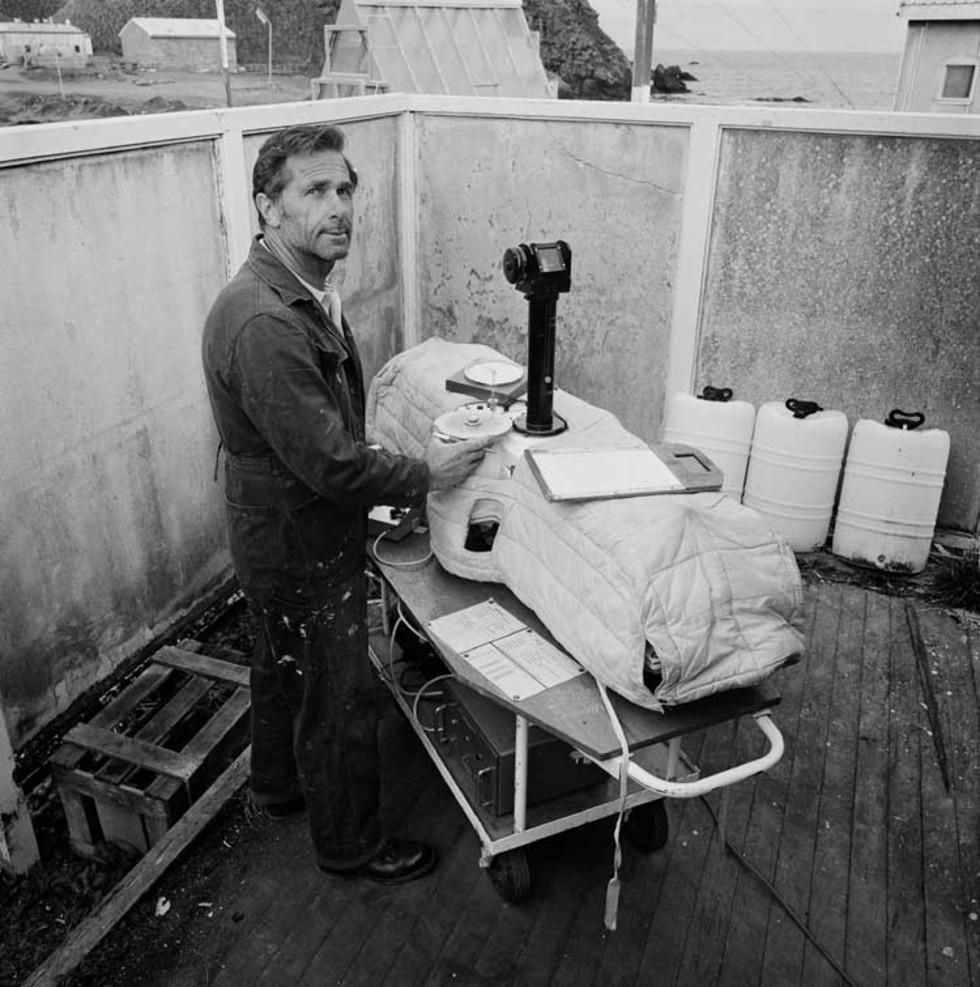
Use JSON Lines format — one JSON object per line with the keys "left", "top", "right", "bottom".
{"left": 203, "top": 125, "right": 489, "bottom": 883}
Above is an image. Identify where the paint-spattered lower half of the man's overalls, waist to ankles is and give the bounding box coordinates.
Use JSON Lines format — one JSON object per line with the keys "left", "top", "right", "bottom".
{"left": 225, "top": 456, "right": 381, "bottom": 869}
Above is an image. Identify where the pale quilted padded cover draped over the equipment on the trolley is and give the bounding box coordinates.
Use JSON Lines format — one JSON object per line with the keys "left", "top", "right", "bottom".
{"left": 368, "top": 338, "right": 803, "bottom": 710}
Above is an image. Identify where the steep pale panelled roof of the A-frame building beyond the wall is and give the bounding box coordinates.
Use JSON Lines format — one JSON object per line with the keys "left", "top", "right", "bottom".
{"left": 330, "top": 0, "right": 555, "bottom": 98}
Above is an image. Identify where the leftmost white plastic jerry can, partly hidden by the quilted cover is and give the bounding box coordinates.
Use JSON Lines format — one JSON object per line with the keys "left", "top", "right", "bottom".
{"left": 661, "top": 386, "right": 755, "bottom": 501}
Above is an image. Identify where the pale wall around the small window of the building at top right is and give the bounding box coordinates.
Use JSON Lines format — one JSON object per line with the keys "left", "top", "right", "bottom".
{"left": 895, "top": 20, "right": 980, "bottom": 113}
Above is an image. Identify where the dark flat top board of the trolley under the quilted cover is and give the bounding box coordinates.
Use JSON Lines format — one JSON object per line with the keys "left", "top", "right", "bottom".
{"left": 374, "top": 533, "right": 779, "bottom": 759}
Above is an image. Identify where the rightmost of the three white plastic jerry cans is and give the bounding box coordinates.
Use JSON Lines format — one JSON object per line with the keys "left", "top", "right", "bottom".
{"left": 831, "top": 408, "right": 949, "bottom": 573}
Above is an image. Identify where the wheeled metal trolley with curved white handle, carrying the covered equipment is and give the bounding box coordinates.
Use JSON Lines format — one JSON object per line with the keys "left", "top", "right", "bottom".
{"left": 370, "top": 534, "right": 784, "bottom": 903}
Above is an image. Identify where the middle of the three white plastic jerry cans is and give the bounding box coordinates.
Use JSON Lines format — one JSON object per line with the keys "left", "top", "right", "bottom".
{"left": 742, "top": 398, "right": 847, "bottom": 552}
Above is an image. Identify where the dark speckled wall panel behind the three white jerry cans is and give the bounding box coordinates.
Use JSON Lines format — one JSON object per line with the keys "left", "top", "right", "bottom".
{"left": 697, "top": 130, "right": 980, "bottom": 531}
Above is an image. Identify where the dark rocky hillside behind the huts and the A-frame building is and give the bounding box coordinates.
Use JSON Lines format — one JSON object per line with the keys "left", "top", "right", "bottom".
{"left": 34, "top": 0, "right": 630, "bottom": 100}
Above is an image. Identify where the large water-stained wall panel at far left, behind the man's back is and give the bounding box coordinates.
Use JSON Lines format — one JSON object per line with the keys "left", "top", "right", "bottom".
{"left": 0, "top": 142, "right": 227, "bottom": 744}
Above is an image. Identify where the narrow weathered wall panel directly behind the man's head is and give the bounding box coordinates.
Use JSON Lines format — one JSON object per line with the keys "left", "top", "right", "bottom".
{"left": 245, "top": 113, "right": 405, "bottom": 378}
